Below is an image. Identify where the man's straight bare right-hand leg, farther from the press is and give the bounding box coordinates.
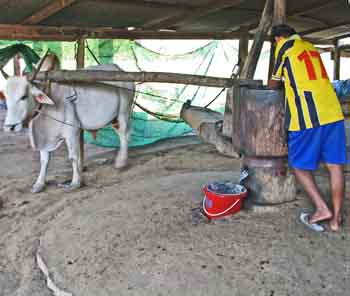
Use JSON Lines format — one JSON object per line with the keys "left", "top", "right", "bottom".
{"left": 326, "top": 164, "right": 344, "bottom": 231}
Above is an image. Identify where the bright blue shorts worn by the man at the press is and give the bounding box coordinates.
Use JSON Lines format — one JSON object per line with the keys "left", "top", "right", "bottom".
{"left": 288, "top": 120, "right": 348, "bottom": 170}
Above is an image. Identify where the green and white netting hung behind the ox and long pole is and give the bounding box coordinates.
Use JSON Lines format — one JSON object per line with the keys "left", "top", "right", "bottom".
{"left": 0, "top": 40, "right": 252, "bottom": 147}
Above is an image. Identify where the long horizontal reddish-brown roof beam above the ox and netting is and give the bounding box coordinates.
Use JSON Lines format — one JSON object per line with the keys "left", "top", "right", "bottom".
{"left": 0, "top": 24, "right": 254, "bottom": 41}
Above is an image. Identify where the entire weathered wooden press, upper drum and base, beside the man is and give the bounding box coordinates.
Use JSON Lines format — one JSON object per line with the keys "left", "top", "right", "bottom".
{"left": 227, "top": 83, "right": 296, "bottom": 205}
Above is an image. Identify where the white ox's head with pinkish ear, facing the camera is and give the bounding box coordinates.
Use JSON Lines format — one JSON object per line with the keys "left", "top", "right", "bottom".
{"left": 4, "top": 76, "right": 54, "bottom": 132}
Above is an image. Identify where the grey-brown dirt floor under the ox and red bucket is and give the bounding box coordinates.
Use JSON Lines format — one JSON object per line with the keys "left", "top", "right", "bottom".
{"left": 0, "top": 109, "right": 350, "bottom": 296}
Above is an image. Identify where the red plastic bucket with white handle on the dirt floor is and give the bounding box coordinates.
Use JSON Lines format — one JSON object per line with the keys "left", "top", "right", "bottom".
{"left": 203, "top": 184, "right": 247, "bottom": 219}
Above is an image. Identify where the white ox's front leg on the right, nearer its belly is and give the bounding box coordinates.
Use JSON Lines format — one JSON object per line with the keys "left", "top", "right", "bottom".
{"left": 66, "top": 135, "right": 81, "bottom": 189}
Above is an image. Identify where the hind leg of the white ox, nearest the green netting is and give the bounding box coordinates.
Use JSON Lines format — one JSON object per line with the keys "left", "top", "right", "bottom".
{"left": 112, "top": 118, "right": 129, "bottom": 169}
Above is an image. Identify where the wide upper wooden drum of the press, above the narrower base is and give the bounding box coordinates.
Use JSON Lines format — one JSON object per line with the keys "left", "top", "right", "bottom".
{"left": 232, "top": 86, "right": 288, "bottom": 157}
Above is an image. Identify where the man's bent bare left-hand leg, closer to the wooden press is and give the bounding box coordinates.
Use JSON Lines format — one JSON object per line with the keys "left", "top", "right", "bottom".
{"left": 294, "top": 169, "right": 332, "bottom": 223}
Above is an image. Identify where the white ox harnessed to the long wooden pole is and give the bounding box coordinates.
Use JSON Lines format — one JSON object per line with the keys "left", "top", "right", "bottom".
{"left": 5, "top": 65, "right": 135, "bottom": 193}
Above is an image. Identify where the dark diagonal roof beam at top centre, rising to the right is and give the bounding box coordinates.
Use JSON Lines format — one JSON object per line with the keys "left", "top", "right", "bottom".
{"left": 143, "top": 0, "right": 244, "bottom": 29}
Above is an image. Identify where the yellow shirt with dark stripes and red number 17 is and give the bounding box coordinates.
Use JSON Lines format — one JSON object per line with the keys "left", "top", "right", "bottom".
{"left": 272, "top": 35, "right": 344, "bottom": 131}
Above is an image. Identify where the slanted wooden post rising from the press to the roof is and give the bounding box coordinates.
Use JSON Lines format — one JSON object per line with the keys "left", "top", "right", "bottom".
{"left": 240, "top": 0, "right": 274, "bottom": 79}
